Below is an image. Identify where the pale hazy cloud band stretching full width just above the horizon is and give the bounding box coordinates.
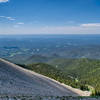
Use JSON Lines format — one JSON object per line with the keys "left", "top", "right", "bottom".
{"left": 0, "top": 22, "right": 100, "bottom": 34}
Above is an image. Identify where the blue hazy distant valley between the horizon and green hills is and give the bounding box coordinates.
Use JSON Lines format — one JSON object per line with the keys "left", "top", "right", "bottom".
{"left": 0, "top": 35, "right": 100, "bottom": 63}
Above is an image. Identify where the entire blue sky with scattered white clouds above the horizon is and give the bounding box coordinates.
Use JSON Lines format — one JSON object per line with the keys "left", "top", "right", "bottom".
{"left": 0, "top": 0, "right": 100, "bottom": 34}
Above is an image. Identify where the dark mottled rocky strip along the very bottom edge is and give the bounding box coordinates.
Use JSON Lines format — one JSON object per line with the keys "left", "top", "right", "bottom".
{"left": 0, "top": 95, "right": 100, "bottom": 100}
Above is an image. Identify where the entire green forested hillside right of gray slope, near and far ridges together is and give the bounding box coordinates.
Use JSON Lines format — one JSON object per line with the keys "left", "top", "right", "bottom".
{"left": 17, "top": 58, "right": 100, "bottom": 95}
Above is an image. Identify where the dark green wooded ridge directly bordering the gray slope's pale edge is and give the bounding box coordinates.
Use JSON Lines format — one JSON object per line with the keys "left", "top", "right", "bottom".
{"left": 20, "top": 63, "right": 88, "bottom": 90}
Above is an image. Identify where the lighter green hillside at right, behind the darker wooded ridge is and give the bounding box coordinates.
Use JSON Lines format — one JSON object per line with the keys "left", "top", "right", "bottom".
{"left": 49, "top": 58, "right": 100, "bottom": 95}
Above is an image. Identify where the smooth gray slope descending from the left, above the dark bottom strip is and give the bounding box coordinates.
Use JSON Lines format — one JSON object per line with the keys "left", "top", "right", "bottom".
{"left": 0, "top": 59, "right": 78, "bottom": 96}
